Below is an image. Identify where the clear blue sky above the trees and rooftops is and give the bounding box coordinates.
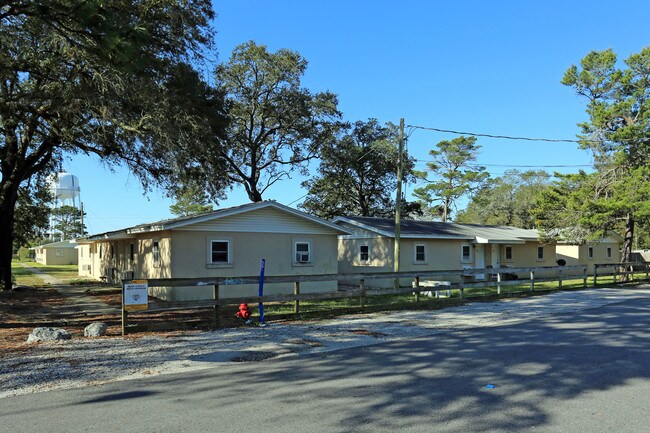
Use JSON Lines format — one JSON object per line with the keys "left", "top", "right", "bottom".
{"left": 64, "top": 0, "right": 650, "bottom": 233}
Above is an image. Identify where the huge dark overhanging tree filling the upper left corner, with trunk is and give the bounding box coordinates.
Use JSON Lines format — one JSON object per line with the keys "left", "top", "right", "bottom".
{"left": 0, "top": 0, "right": 222, "bottom": 289}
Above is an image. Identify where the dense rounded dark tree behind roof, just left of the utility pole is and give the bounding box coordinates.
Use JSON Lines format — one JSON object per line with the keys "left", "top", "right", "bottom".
{"left": 300, "top": 119, "right": 419, "bottom": 219}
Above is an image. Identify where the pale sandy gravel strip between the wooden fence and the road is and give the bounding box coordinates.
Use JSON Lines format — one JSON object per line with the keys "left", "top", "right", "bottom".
{"left": 0, "top": 285, "right": 650, "bottom": 398}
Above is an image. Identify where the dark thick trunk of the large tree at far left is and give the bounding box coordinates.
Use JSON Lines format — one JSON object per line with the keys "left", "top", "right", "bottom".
{"left": 0, "top": 183, "right": 18, "bottom": 290}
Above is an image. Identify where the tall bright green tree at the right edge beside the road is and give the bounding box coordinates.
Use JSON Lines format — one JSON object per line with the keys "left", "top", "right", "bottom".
{"left": 562, "top": 47, "right": 650, "bottom": 261}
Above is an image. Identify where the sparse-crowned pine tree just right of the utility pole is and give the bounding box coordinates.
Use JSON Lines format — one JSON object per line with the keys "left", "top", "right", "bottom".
{"left": 413, "top": 136, "right": 489, "bottom": 222}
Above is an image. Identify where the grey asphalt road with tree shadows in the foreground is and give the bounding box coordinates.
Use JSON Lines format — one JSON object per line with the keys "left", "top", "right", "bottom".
{"left": 0, "top": 300, "right": 650, "bottom": 433}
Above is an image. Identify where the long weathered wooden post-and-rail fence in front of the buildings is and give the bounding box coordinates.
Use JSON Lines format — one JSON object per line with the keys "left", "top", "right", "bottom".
{"left": 122, "top": 263, "right": 650, "bottom": 335}
